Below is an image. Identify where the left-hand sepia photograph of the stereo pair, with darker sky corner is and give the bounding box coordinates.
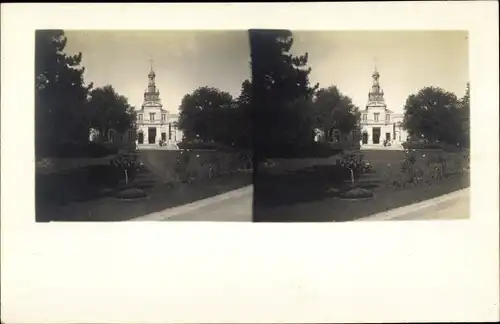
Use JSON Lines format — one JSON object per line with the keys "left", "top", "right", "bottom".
{"left": 35, "top": 30, "right": 252, "bottom": 222}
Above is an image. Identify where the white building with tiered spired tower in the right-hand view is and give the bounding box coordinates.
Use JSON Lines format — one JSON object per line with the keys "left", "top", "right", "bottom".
{"left": 360, "top": 68, "right": 407, "bottom": 146}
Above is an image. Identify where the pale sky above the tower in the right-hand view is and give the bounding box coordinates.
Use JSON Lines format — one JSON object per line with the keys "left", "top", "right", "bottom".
{"left": 292, "top": 31, "right": 469, "bottom": 113}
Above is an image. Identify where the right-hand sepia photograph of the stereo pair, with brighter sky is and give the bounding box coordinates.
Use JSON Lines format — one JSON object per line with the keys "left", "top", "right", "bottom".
{"left": 251, "top": 30, "right": 470, "bottom": 222}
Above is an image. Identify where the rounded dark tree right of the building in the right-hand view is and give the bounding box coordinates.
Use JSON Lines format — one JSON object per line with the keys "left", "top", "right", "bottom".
{"left": 403, "top": 87, "right": 461, "bottom": 145}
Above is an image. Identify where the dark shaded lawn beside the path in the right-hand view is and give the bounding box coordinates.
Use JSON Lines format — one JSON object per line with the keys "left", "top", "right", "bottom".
{"left": 253, "top": 151, "right": 469, "bottom": 222}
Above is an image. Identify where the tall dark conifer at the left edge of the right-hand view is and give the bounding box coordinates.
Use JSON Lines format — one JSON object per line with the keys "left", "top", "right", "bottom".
{"left": 250, "top": 30, "right": 318, "bottom": 151}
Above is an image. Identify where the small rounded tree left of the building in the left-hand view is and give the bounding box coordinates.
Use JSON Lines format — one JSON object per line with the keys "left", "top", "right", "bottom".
{"left": 88, "top": 85, "right": 135, "bottom": 136}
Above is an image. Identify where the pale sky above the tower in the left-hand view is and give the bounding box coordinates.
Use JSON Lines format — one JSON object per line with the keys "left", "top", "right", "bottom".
{"left": 65, "top": 30, "right": 251, "bottom": 113}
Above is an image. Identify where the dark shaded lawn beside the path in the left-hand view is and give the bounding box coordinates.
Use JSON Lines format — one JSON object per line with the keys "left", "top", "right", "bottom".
{"left": 36, "top": 151, "right": 252, "bottom": 222}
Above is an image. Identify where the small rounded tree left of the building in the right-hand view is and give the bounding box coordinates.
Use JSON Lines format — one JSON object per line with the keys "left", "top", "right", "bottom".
{"left": 313, "top": 86, "right": 360, "bottom": 134}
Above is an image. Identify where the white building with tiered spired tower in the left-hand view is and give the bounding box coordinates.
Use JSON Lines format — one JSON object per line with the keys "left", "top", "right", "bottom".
{"left": 136, "top": 61, "right": 182, "bottom": 147}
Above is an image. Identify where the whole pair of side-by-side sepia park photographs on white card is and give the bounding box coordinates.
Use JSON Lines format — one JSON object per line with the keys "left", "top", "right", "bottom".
{"left": 34, "top": 30, "right": 470, "bottom": 222}
